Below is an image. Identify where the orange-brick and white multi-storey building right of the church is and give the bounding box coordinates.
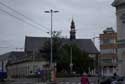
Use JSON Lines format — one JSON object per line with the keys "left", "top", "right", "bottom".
{"left": 100, "top": 28, "right": 117, "bottom": 76}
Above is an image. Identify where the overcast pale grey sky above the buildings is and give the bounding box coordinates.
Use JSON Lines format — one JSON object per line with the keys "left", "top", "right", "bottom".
{"left": 0, "top": 0, "right": 116, "bottom": 54}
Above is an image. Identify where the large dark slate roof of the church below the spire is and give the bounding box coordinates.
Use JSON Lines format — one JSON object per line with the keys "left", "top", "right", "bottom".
{"left": 25, "top": 37, "right": 99, "bottom": 54}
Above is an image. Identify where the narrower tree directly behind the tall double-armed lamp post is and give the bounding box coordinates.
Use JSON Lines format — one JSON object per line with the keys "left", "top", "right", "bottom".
{"left": 41, "top": 31, "right": 62, "bottom": 62}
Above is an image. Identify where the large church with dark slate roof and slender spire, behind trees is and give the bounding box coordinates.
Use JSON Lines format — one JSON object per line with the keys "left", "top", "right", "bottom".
{"left": 25, "top": 20, "right": 99, "bottom": 74}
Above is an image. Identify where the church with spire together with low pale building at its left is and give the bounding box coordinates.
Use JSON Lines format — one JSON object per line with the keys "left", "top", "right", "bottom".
{"left": 0, "top": 20, "right": 99, "bottom": 77}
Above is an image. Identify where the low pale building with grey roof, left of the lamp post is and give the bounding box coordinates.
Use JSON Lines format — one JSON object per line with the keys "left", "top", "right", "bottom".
{"left": 2, "top": 51, "right": 48, "bottom": 78}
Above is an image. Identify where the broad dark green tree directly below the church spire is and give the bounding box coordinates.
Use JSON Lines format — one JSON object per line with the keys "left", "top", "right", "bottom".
{"left": 57, "top": 44, "right": 94, "bottom": 74}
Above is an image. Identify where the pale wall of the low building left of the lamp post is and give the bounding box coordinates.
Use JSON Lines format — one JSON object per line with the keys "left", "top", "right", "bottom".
{"left": 7, "top": 61, "right": 47, "bottom": 77}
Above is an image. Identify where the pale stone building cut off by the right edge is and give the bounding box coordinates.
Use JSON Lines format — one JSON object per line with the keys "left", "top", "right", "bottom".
{"left": 112, "top": 0, "right": 125, "bottom": 76}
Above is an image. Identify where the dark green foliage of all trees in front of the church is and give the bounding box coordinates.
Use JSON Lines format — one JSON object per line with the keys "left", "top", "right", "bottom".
{"left": 42, "top": 33, "right": 95, "bottom": 74}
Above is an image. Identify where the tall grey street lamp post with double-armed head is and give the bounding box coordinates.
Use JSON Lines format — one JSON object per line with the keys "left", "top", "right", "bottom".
{"left": 45, "top": 9, "right": 59, "bottom": 81}
